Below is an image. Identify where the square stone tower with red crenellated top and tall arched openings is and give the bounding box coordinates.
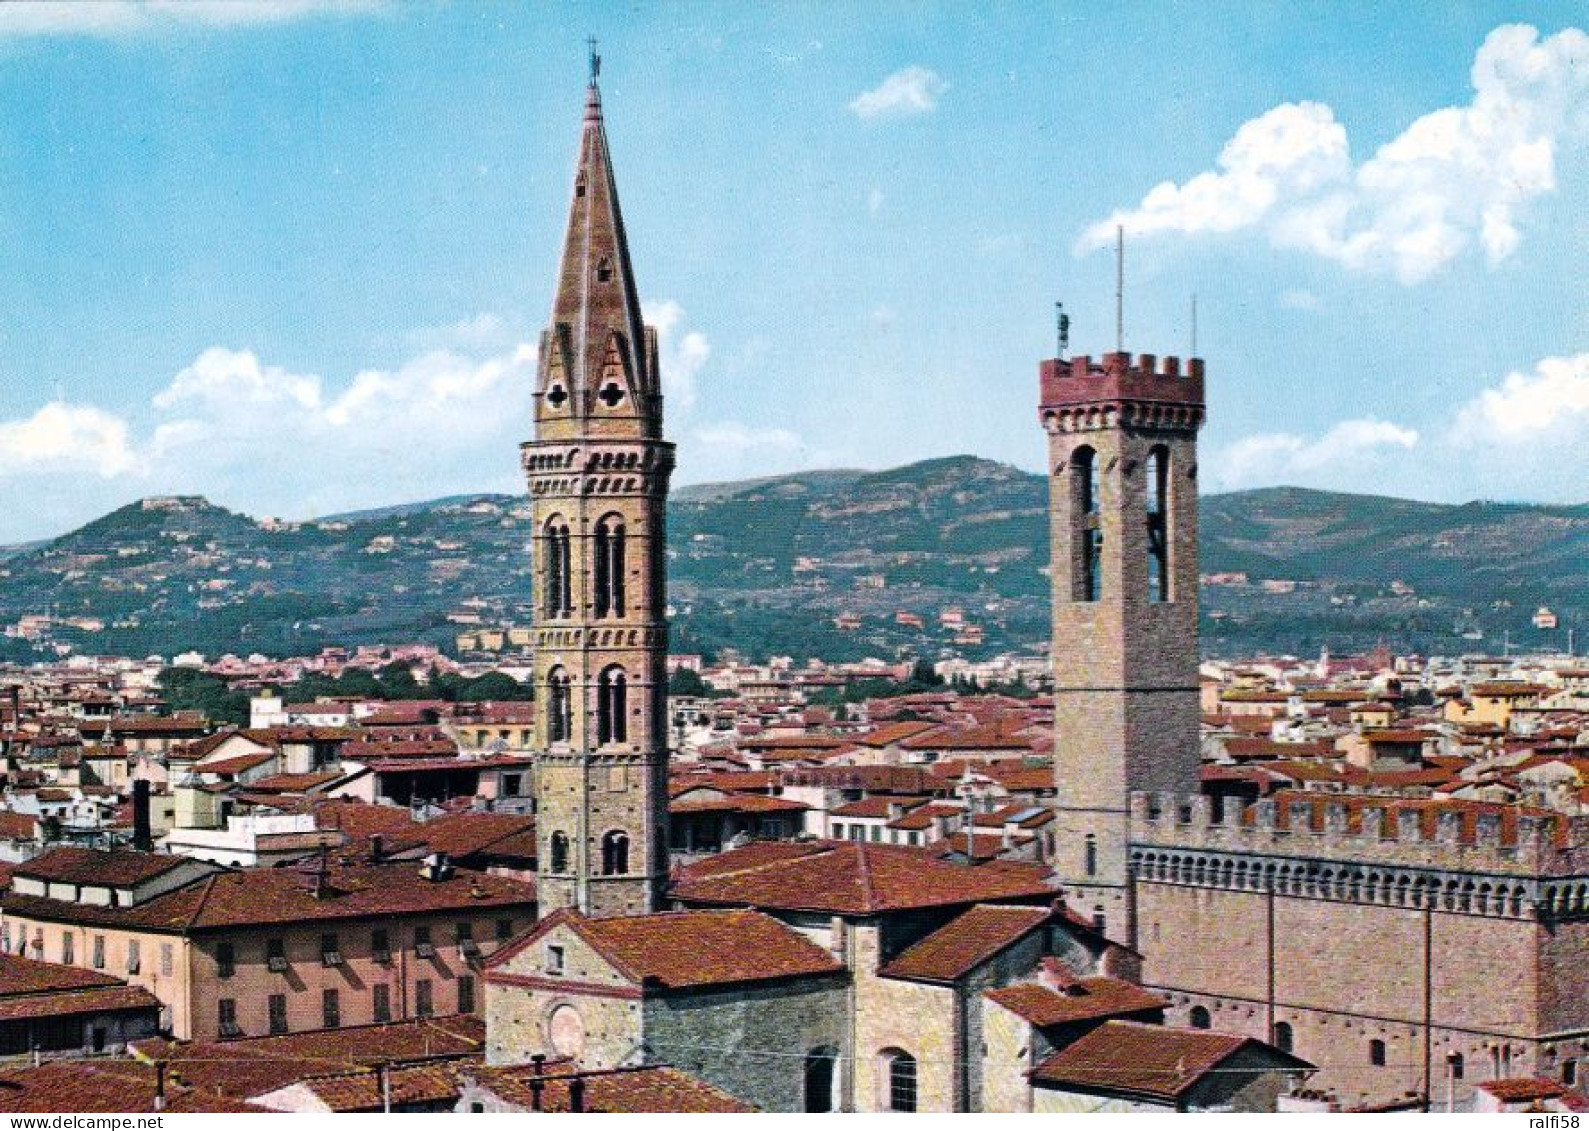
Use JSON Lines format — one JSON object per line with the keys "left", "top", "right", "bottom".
{"left": 1039, "top": 353, "right": 1203, "bottom": 942}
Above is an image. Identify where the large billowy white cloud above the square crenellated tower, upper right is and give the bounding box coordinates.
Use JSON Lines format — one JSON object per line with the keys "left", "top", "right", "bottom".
{"left": 1076, "top": 24, "right": 1589, "bottom": 284}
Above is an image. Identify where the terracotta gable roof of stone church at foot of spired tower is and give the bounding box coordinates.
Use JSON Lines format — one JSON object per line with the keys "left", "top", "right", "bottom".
{"left": 486, "top": 910, "right": 844, "bottom": 990}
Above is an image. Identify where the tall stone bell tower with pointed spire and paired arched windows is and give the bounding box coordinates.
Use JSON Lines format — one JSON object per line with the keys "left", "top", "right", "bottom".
{"left": 523, "top": 59, "right": 674, "bottom": 915}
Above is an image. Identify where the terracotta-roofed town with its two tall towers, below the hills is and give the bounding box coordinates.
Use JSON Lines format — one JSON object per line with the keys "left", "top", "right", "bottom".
{"left": 0, "top": 35, "right": 1589, "bottom": 1115}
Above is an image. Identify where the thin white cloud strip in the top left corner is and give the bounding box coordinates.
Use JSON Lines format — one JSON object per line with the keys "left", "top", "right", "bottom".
{"left": 0, "top": 0, "right": 385, "bottom": 38}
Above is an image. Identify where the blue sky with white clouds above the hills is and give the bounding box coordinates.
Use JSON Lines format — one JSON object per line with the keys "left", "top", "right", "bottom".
{"left": 0, "top": 0, "right": 1589, "bottom": 540}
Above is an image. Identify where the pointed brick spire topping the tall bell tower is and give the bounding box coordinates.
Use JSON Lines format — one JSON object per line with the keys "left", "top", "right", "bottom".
{"left": 539, "top": 47, "right": 661, "bottom": 434}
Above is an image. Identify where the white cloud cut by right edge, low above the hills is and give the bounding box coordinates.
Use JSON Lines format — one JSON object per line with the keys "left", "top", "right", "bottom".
{"left": 1451, "top": 353, "right": 1589, "bottom": 444}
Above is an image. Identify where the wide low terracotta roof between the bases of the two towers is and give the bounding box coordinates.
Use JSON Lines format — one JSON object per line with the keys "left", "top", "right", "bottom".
{"left": 672, "top": 840, "right": 1054, "bottom": 915}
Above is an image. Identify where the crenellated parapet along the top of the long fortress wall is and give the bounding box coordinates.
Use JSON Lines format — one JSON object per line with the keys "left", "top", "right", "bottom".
{"left": 1130, "top": 793, "right": 1589, "bottom": 880}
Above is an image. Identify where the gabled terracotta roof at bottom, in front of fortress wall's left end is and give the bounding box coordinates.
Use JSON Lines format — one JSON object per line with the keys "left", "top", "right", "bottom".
{"left": 1031, "top": 1021, "right": 1311, "bottom": 1101}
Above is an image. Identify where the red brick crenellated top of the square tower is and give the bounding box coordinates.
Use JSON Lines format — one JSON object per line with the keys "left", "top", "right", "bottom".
{"left": 1038, "top": 353, "right": 1203, "bottom": 429}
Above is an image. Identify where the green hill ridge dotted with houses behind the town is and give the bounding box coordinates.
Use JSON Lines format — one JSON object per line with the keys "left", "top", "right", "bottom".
{"left": 0, "top": 456, "right": 1589, "bottom": 659}
